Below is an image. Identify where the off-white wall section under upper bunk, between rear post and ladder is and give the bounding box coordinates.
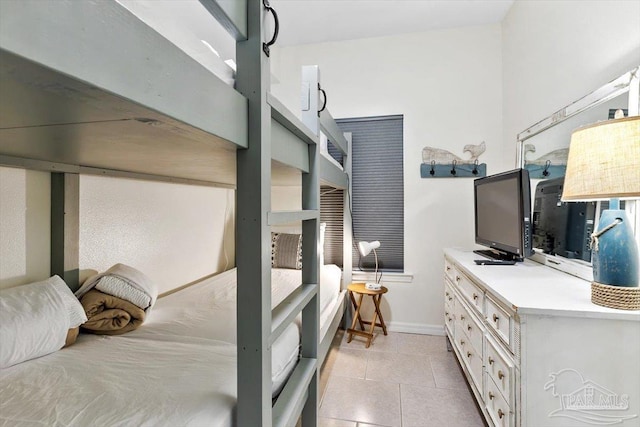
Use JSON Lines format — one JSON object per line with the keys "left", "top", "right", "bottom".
{"left": 80, "top": 176, "right": 235, "bottom": 292}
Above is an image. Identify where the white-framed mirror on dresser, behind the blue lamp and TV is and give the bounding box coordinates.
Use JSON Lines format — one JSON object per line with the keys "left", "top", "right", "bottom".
{"left": 516, "top": 67, "right": 640, "bottom": 280}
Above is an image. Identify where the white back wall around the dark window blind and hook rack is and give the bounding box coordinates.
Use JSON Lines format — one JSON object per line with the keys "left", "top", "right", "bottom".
{"left": 272, "top": 25, "right": 504, "bottom": 333}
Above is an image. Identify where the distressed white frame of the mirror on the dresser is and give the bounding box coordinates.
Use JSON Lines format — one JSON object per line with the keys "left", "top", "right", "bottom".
{"left": 516, "top": 66, "right": 640, "bottom": 281}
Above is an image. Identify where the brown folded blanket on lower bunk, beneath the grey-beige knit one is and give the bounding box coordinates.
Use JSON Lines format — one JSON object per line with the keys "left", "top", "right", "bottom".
{"left": 80, "top": 289, "right": 145, "bottom": 335}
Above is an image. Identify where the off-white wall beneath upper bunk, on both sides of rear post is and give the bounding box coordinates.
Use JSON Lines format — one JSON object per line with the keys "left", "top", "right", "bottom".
{"left": 0, "top": 168, "right": 235, "bottom": 293}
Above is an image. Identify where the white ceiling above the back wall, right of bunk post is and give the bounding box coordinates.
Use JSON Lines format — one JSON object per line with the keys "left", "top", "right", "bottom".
{"left": 270, "top": 0, "right": 514, "bottom": 46}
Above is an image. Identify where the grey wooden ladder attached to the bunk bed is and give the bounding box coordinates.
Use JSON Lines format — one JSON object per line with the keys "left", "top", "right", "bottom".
{"left": 236, "top": 0, "right": 320, "bottom": 427}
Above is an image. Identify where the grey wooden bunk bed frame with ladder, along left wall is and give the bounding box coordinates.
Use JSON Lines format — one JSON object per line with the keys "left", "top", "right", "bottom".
{"left": 0, "top": 0, "right": 351, "bottom": 426}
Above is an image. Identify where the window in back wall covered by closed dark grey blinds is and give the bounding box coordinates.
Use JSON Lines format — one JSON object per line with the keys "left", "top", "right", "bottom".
{"left": 329, "top": 115, "right": 404, "bottom": 271}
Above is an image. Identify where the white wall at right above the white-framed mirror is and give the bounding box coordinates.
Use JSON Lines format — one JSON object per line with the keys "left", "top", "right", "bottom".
{"left": 502, "top": 0, "right": 640, "bottom": 166}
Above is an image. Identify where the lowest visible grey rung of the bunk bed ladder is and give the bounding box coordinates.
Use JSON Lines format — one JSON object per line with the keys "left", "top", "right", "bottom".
{"left": 273, "top": 357, "right": 317, "bottom": 426}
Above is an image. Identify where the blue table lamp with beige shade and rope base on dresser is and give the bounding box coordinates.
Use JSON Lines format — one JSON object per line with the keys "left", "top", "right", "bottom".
{"left": 562, "top": 116, "right": 640, "bottom": 310}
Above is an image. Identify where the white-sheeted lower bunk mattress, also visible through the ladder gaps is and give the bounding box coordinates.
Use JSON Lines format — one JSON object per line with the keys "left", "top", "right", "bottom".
{"left": 0, "top": 266, "right": 340, "bottom": 426}
